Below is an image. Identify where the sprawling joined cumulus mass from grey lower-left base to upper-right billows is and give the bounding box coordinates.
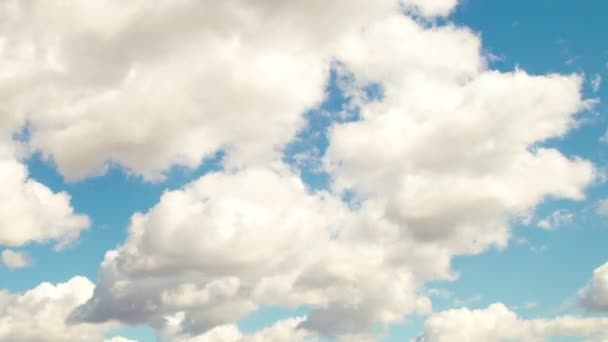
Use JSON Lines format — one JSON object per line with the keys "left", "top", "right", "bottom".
{"left": 63, "top": 0, "right": 594, "bottom": 338}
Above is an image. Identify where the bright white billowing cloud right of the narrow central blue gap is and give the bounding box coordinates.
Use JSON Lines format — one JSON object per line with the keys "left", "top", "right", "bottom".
{"left": 325, "top": 16, "right": 594, "bottom": 253}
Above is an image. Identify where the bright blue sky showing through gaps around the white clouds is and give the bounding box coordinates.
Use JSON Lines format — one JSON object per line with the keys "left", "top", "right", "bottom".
{"left": 0, "top": 0, "right": 608, "bottom": 342}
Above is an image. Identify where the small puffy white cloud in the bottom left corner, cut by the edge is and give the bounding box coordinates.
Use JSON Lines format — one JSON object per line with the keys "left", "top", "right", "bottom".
{"left": 0, "top": 277, "right": 116, "bottom": 342}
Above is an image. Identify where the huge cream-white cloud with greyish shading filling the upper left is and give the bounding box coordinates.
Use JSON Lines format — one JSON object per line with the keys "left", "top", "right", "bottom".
{"left": 0, "top": 0, "right": 399, "bottom": 179}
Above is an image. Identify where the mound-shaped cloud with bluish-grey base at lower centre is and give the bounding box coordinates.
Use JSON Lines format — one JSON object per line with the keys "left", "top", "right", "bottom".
{"left": 72, "top": 167, "right": 432, "bottom": 335}
